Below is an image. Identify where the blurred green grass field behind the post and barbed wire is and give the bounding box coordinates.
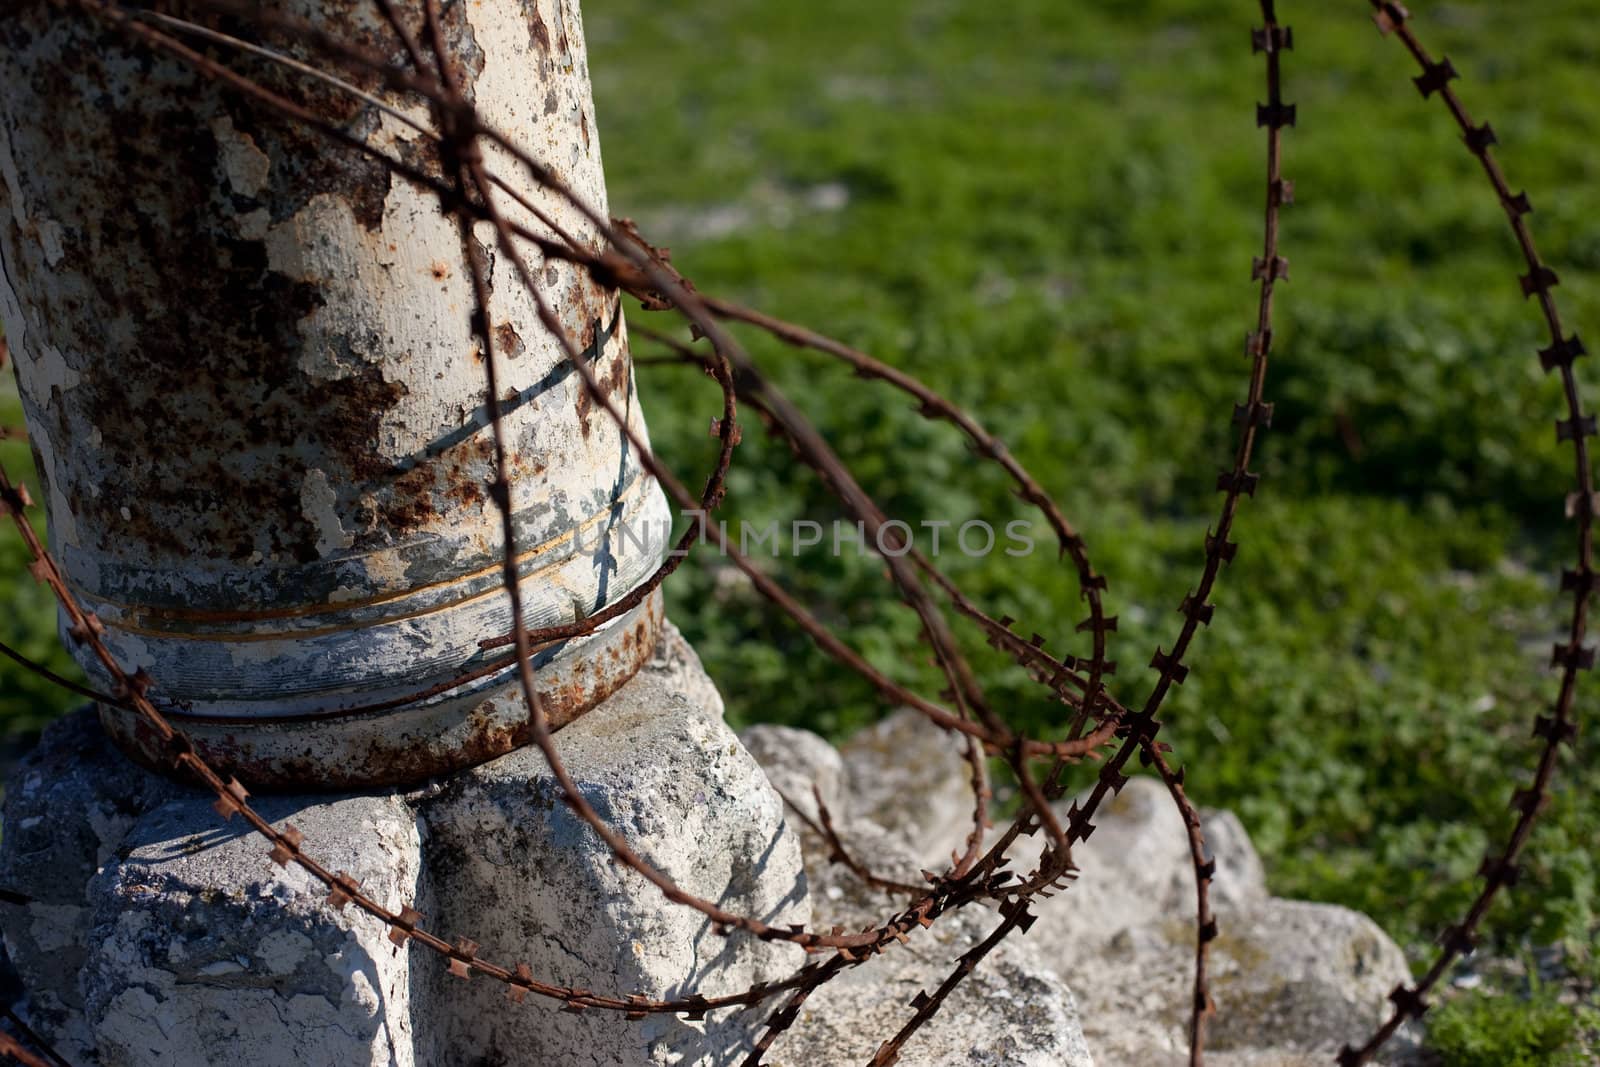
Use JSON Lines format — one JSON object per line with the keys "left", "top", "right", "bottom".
{"left": 0, "top": 0, "right": 1600, "bottom": 1049}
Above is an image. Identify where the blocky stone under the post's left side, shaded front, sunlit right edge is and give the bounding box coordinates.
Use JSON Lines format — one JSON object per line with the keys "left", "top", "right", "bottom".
{"left": 80, "top": 795, "right": 426, "bottom": 1067}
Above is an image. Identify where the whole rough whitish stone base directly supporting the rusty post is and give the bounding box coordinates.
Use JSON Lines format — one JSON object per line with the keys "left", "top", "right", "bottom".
{"left": 0, "top": 624, "right": 811, "bottom": 1067}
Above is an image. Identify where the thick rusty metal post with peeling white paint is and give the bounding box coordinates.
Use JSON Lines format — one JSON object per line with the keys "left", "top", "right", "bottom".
{"left": 0, "top": 0, "right": 669, "bottom": 789}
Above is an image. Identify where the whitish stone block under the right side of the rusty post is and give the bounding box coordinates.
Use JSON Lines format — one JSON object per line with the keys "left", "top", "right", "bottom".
{"left": 421, "top": 627, "right": 811, "bottom": 1067}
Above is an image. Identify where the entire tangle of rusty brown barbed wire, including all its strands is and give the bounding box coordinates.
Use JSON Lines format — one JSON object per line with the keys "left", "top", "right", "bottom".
{"left": 0, "top": 0, "right": 1600, "bottom": 1067}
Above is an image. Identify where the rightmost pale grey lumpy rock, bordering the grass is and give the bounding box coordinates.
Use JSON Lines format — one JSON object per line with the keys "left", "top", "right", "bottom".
{"left": 1018, "top": 776, "right": 1410, "bottom": 1067}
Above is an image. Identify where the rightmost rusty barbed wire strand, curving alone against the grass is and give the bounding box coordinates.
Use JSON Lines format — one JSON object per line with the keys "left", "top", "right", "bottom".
{"left": 1338, "top": 0, "right": 1600, "bottom": 1067}
